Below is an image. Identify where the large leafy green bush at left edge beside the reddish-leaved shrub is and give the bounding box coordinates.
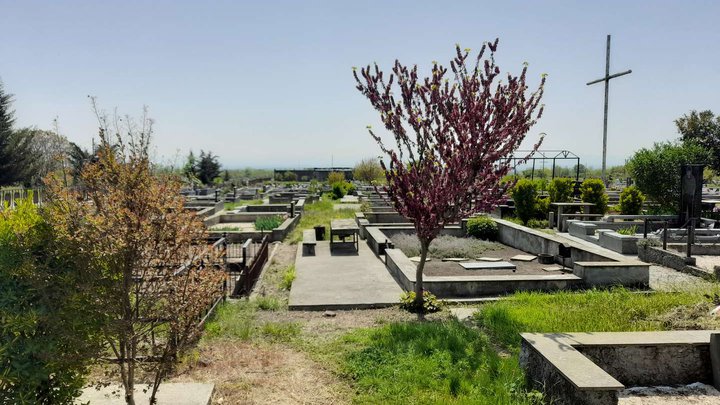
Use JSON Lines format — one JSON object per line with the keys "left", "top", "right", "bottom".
{"left": 0, "top": 197, "right": 102, "bottom": 404}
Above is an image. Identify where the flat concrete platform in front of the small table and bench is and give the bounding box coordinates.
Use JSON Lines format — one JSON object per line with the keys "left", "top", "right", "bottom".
{"left": 288, "top": 241, "right": 403, "bottom": 311}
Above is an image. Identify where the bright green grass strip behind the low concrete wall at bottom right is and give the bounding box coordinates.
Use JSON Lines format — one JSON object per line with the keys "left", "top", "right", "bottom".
{"left": 474, "top": 288, "right": 708, "bottom": 349}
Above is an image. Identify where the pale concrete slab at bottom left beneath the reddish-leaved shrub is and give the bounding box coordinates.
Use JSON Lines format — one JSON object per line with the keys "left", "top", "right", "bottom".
{"left": 77, "top": 383, "right": 215, "bottom": 405}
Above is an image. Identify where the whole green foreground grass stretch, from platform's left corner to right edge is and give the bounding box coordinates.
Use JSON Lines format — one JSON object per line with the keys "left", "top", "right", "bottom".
{"left": 206, "top": 288, "right": 720, "bottom": 405}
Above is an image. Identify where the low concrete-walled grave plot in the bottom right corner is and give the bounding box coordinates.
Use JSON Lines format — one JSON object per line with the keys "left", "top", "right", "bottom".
{"left": 520, "top": 331, "right": 720, "bottom": 405}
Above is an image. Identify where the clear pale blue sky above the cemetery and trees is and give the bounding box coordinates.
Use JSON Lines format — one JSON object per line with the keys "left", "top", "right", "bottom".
{"left": 0, "top": 0, "right": 720, "bottom": 168}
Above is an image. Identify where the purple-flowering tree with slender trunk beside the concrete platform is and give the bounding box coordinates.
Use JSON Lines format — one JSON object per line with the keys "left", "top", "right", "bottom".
{"left": 353, "top": 40, "right": 545, "bottom": 308}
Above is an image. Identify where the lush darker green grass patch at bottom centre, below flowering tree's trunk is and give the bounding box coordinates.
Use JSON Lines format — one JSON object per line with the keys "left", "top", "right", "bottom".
{"left": 342, "top": 320, "right": 540, "bottom": 404}
